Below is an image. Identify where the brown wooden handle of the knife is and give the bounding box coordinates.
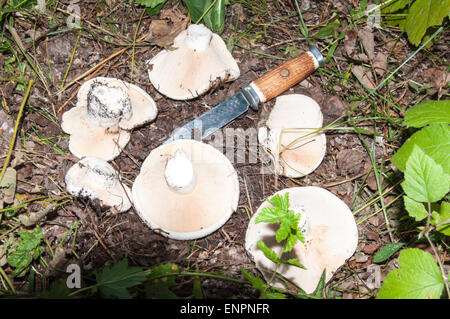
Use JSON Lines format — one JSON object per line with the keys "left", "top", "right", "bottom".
{"left": 250, "top": 49, "right": 323, "bottom": 102}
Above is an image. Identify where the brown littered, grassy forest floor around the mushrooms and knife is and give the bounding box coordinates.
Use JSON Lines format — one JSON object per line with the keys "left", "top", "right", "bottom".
{"left": 0, "top": 0, "right": 450, "bottom": 299}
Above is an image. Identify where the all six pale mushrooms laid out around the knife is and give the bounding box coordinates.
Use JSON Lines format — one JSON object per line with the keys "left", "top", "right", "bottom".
{"left": 61, "top": 24, "right": 358, "bottom": 292}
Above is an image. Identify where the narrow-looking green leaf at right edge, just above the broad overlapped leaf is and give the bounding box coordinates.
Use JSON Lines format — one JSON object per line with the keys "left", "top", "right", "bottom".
{"left": 404, "top": 100, "right": 450, "bottom": 127}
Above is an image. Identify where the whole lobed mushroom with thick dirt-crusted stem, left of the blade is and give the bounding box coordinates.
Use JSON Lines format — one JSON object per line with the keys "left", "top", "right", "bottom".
{"left": 61, "top": 77, "right": 157, "bottom": 161}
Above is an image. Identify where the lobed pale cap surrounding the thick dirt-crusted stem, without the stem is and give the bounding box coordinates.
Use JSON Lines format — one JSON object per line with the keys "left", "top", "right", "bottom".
{"left": 61, "top": 77, "right": 158, "bottom": 161}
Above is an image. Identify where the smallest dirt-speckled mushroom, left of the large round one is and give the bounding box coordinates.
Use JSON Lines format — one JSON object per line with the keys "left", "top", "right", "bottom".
{"left": 65, "top": 157, "right": 131, "bottom": 212}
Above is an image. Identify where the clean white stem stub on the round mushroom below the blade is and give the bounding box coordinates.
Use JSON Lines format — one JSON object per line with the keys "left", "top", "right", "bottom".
{"left": 164, "top": 149, "right": 196, "bottom": 194}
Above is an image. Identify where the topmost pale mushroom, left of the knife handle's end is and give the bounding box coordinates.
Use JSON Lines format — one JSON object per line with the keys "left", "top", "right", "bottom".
{"left": 148, "top": 24, "right": 240, "bottom": 100}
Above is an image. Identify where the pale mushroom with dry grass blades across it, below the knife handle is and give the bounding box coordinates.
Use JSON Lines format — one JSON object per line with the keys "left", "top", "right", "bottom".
{"left": 258, "top": 94, "right": 326, "bottom": 178}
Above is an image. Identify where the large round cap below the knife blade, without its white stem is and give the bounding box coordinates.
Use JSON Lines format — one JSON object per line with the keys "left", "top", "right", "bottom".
{"left": 132, "top": 140, "right": 239, "bottom": 240}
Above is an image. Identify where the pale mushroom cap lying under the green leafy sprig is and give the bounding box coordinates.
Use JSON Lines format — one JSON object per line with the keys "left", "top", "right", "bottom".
{"left": 245, "top": 186, "right": 358, "bottom": 293}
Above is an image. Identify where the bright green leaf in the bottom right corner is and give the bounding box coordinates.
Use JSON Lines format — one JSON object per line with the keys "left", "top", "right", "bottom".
{"left": 377, "top": 248, "right": 444, "bottom": 299}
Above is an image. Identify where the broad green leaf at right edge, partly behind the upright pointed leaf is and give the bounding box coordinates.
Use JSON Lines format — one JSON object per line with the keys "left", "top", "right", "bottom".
{"left": 391, "top": 123, "right": 450, "bottom": 175}
